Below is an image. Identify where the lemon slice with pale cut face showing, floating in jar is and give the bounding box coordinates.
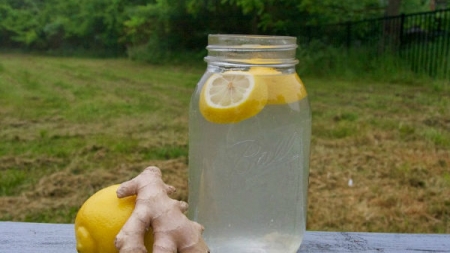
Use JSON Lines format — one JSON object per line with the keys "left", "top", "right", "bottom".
{"left": 199, "top": 71, "right": 267, "bottom": 124}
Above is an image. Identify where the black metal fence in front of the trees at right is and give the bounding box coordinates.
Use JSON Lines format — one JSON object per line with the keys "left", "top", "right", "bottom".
{"left": 299, "top": 9, "right": 450, "bottom": 79}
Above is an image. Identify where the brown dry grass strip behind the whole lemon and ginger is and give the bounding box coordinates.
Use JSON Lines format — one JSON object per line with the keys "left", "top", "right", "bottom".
{"left": 0, "top": 158, "right": 187, "bottom": 223}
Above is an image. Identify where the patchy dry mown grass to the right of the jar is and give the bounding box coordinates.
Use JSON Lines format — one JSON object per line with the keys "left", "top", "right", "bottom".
{"left": 308, "top": 80, "right": 450, "bottom": 233}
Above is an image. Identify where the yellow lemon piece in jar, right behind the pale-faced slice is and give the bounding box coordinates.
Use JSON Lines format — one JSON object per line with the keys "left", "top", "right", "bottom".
{"left": 249, "top": 67, "right": 307, "bottom": 105}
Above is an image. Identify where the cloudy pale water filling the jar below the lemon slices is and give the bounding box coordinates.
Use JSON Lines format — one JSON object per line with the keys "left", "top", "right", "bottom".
{"left": 188, "top": 67, "right": 311, "bottom": 253}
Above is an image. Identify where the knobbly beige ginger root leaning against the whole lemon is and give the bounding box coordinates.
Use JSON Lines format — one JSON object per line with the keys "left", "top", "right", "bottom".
{"left": 115, "top": 166, "right": 209, "bottom": 253}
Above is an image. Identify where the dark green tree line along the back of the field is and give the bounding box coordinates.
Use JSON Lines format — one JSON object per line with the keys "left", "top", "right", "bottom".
{"left": 0, "top": 0, "right": 434, "bottom": 59}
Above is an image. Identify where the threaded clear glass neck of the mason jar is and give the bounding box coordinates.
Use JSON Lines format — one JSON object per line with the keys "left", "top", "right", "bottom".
{"left": 205, "top": 34, "right": 298, "bottom": 68}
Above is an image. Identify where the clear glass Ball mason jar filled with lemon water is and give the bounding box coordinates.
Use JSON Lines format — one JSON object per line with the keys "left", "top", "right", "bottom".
{"left": 188, "top": 35, "right": 311, "bottom": 253}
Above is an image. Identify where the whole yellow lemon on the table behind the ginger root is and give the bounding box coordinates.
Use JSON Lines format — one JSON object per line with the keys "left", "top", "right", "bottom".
{"left": 75, "top": 185, "right": 153, "bottom": 253}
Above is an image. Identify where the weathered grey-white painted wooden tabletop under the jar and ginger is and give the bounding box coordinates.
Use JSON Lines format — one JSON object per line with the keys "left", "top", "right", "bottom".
{"left": 0, "top": 222, "right": 450, "bottom": 253}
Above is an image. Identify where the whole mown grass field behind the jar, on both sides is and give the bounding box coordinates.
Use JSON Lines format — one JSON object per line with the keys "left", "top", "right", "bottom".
{"left": 0, "top": 54, "right": 450, "bottom": 233}
